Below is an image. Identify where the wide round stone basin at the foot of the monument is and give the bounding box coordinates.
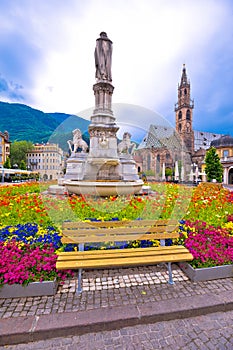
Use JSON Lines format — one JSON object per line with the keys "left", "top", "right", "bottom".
{"left": 64, "top": 180, "right": 144, "bottom": 197}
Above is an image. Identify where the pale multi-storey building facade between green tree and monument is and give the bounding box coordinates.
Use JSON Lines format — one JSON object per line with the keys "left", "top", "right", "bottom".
{"left": 27, "top": 143, "right": 64, "bottom": 180}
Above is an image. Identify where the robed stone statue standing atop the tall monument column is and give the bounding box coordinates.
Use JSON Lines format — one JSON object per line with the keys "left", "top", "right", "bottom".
{"left": 95, "top": 32, "right": 112, "bottom": 81}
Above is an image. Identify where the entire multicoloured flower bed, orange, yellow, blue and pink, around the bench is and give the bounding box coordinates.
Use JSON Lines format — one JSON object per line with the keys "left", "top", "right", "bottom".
{"left": 0, "top": 183, "right": 233, "bottom": 292}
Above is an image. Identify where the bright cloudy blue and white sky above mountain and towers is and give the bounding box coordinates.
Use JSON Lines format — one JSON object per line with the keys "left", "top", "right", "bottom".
{"left": 0, "top": 0, "right": 233, "bottom": 135}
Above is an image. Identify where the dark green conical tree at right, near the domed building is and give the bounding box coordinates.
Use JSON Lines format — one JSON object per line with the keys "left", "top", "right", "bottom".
{"left": 205, "top": 147, "right": 223, "bottom": 182}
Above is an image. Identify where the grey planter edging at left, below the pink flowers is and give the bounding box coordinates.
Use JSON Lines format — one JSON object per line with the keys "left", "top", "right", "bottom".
{"left": 0, "top": 279, "right": 58, "bottom": 299}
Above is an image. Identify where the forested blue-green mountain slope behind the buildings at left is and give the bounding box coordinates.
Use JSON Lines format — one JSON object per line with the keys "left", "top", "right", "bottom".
{"left": 0, "top": 102, "right": 90, "bottom": 150}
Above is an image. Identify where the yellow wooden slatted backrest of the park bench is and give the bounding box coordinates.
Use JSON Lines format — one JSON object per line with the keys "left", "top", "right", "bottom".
{"left": 62, "top": 220, "right": 179, "bottom": 244}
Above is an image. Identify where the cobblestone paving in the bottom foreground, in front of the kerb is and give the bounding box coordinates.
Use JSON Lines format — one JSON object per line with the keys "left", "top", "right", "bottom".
{"left": 0, "top": 311, "right": 233, "bottom": 350}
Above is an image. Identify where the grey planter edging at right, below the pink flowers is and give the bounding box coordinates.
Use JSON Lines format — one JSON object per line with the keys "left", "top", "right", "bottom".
{"left": 179, "top": 262, "right": 233, "bottom": 282}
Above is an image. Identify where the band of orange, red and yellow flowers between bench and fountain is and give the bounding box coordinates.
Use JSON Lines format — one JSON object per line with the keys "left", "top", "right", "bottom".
{"left": 0, "top": 183, "right": 233, "bottom": 227}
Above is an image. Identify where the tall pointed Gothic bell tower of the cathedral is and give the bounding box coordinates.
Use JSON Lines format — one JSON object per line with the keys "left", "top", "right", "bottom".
{"left": 175, "top": 64, "right": 194, "bottom": 156}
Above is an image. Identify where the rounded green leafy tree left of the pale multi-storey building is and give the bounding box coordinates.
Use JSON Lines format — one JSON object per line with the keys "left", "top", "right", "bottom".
{"left": 10, "top": 141, "right": 34, "bottom": 167}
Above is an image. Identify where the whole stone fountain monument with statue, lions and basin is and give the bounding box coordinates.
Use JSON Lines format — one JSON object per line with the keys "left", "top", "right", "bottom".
{"left": 63, "top": 32, "right": 143, "bottom": 196}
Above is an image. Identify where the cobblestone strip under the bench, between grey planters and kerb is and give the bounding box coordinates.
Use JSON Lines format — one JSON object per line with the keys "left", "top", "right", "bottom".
{"left": 0, "top": 265, "right": 233, "bottom": 318}
